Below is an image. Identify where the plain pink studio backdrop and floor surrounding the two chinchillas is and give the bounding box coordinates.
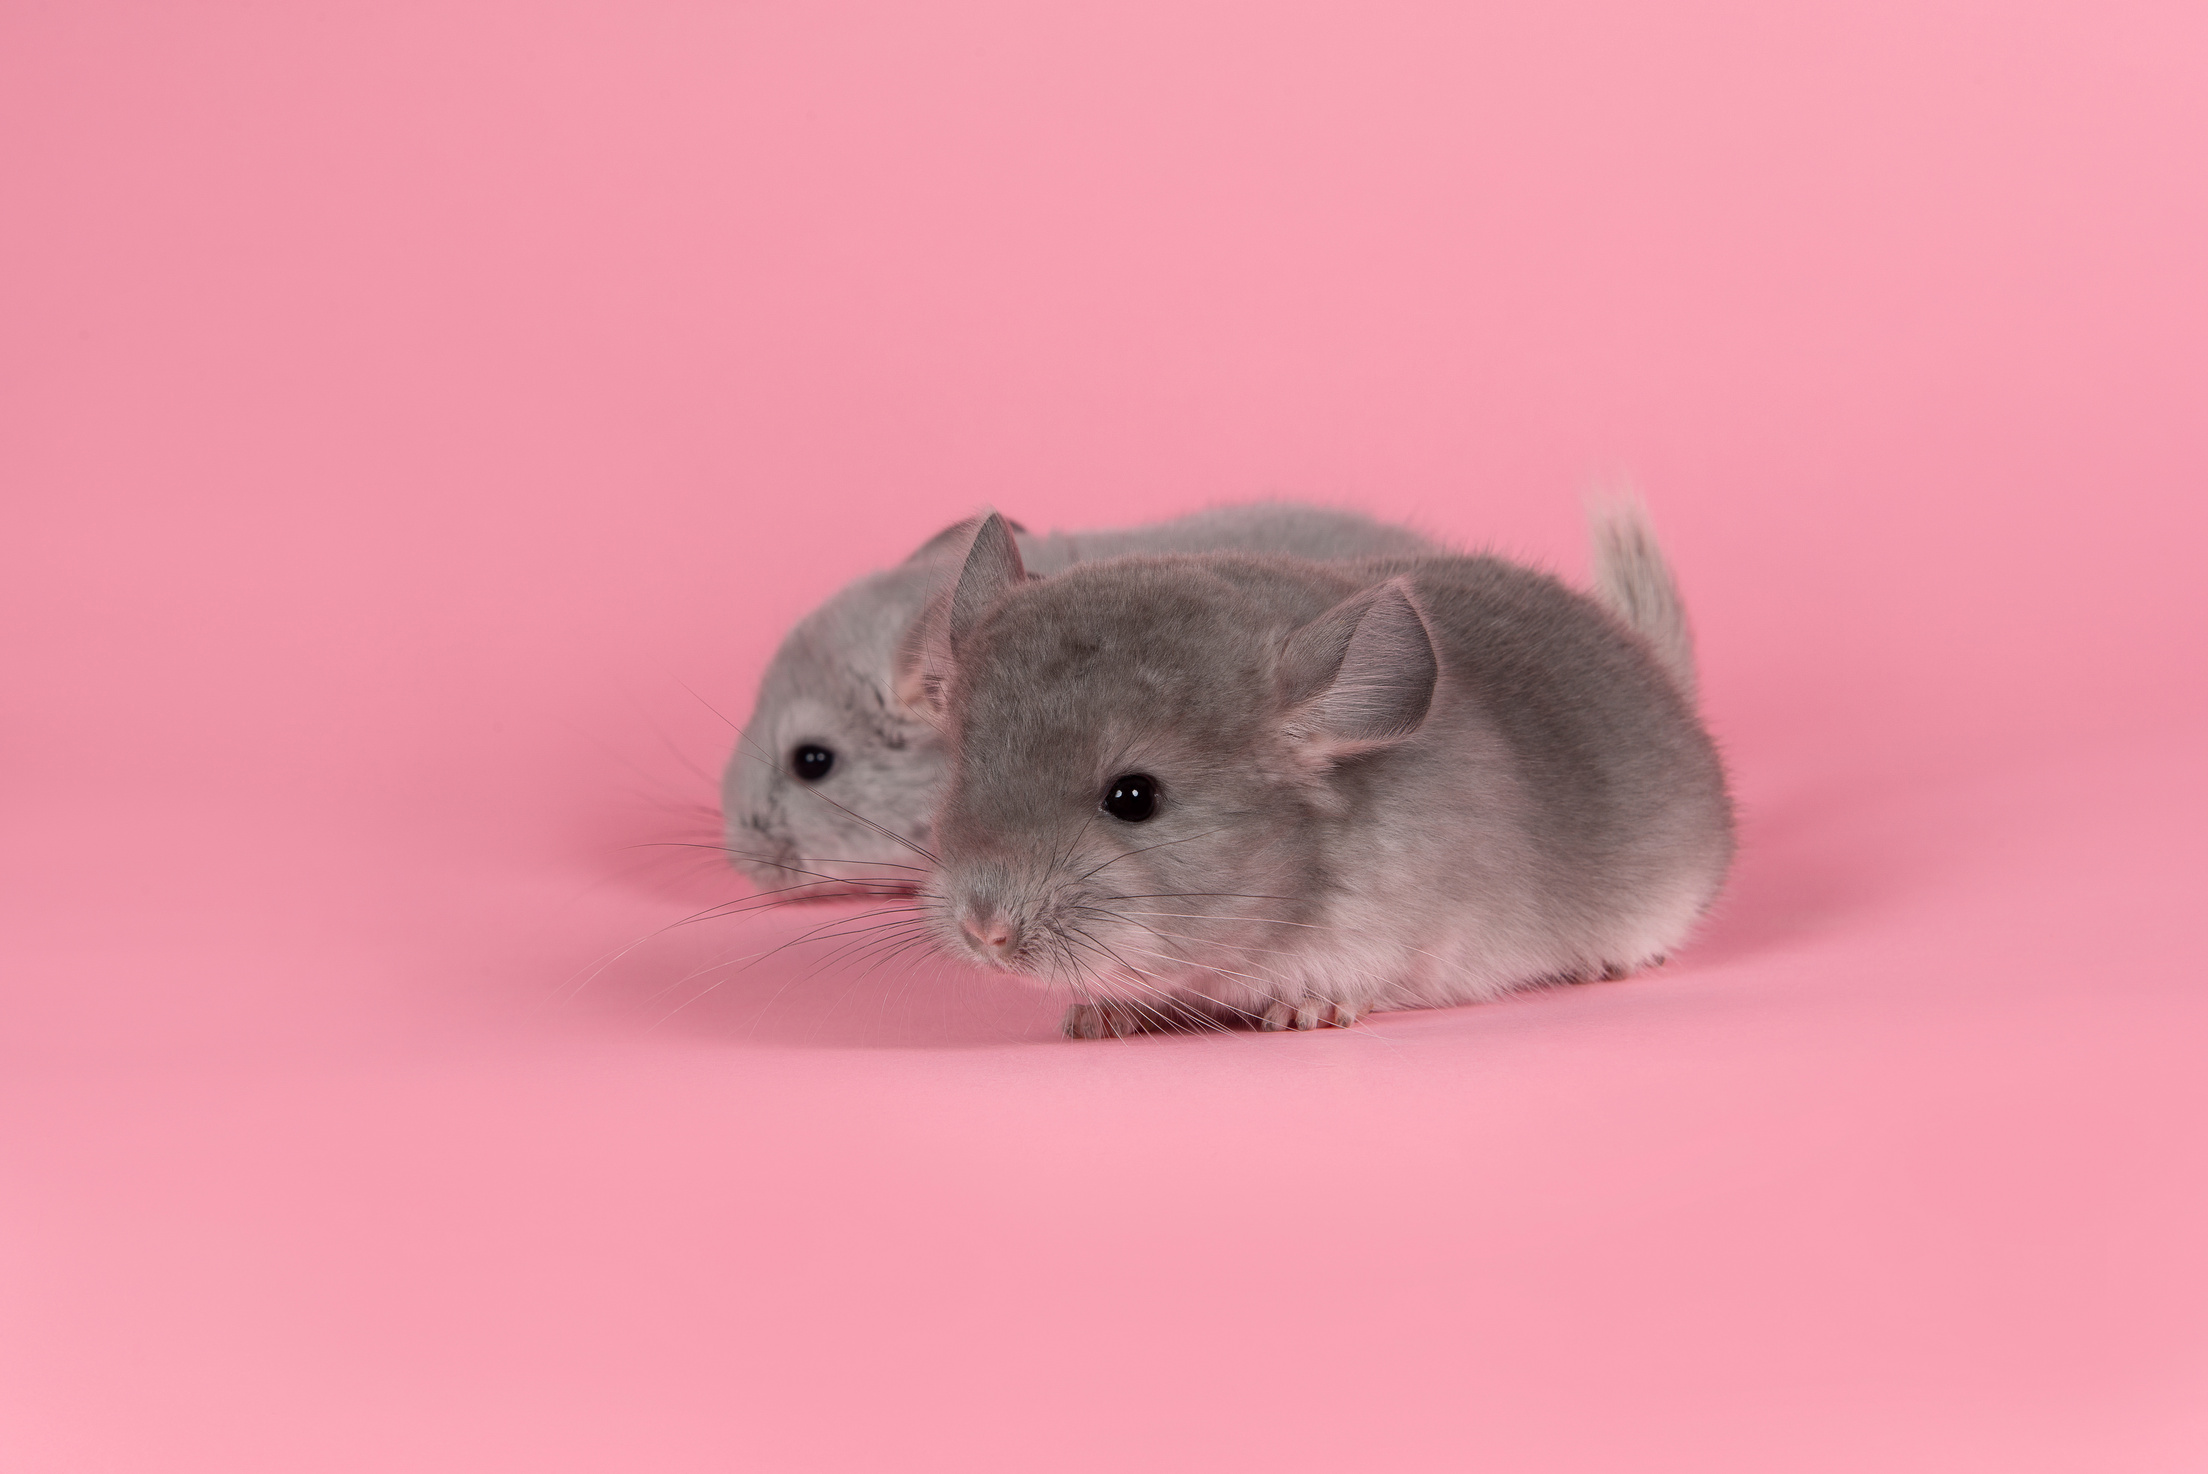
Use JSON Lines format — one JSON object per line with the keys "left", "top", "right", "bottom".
{"left": 0, "top": 0, "right": 2208, "bottom": 1474}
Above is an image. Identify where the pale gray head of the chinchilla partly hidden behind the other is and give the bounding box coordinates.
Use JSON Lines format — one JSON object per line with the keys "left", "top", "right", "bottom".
{"left": 722, "top": 519, "right": 998, "bottom": 898}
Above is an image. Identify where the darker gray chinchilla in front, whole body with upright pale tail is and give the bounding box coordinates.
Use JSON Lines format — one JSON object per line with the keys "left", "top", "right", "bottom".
{"left": 921, "top": 505, "right": 1733, "bottom": 1037}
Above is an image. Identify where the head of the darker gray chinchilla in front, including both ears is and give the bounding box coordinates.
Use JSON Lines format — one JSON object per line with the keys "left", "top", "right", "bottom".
{"left": 916, "top": 519, "right": 1437, "bottom": 1013}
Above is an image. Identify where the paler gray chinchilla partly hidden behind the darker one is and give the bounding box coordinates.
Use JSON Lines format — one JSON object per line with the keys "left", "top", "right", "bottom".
{"left": 722, "top": 501, "right": 1437, "bottom": 898}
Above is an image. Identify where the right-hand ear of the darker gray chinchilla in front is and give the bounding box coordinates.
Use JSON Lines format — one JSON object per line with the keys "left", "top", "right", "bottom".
{"left": 1281, "top": 578, "right": 1442, "bottom": 755}
